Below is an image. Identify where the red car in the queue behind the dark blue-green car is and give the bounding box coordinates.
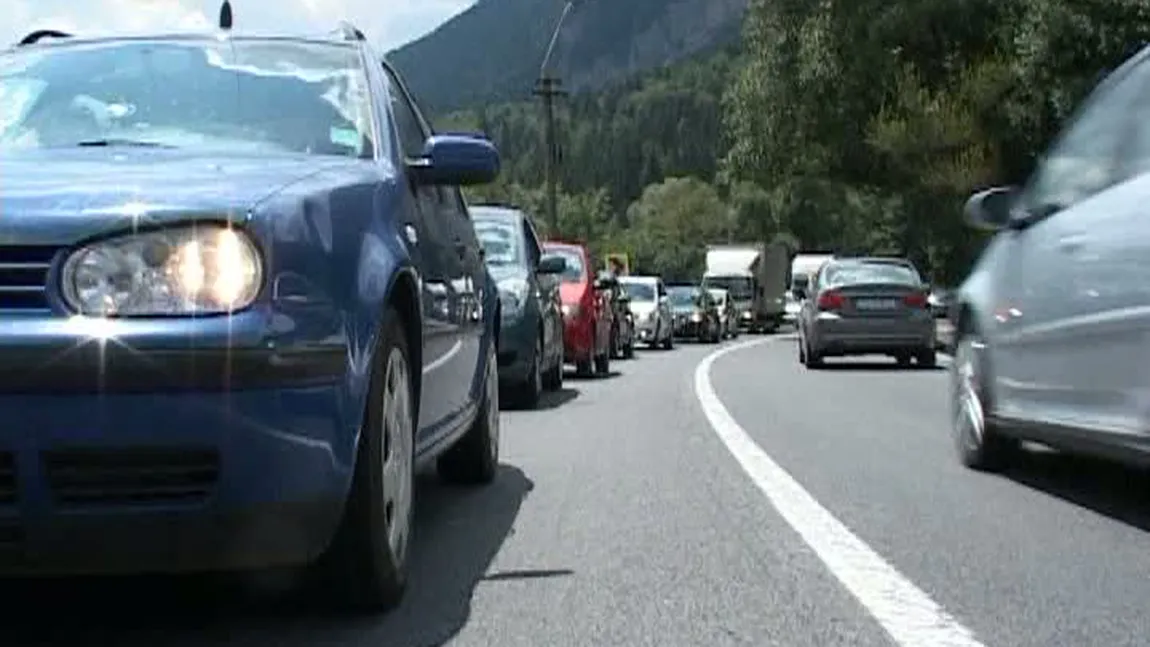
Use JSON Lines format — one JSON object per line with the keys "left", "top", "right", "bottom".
{"left": 543, "top": 242, "right": 614, "bottom": 376}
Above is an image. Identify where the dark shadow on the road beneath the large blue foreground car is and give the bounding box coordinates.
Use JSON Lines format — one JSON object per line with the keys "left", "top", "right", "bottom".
{"left": 0, "top": 465, "right": 533, "bottom": 647}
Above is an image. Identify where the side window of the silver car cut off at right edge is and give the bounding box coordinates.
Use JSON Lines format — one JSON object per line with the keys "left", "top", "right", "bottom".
{"left": 1021, "top": 59, "right": 1144, "bottom": 215}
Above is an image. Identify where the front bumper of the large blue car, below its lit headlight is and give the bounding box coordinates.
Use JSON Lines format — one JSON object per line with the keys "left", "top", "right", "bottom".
{"left": 0, "top": 313, "right": 361, "bottom": 575}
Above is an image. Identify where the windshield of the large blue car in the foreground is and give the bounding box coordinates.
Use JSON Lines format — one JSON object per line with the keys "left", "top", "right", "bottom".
{"left": 0, "top": 39, "right": 375, "bottom": 157}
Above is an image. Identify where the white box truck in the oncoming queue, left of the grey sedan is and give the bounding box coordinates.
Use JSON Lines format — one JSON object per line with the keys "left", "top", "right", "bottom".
{"left": 703, "top": 242, "right": 790, "bottom": 332}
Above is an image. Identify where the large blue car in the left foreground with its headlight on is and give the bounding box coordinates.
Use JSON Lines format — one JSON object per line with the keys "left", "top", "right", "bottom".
{"left": 0, "top": 22, "right": 500, "bottom": 610}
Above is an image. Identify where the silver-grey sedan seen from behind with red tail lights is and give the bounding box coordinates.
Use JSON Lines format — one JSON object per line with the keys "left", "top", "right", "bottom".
{"left": 797, "top": 257, "right": 936, "bottom": 368}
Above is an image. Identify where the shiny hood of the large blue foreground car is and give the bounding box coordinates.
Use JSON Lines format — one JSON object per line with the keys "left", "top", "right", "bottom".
{"left": 0, "top": 148, "right": 348, "bottom": 245}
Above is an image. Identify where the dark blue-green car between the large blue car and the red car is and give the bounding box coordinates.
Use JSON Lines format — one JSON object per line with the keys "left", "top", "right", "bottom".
{"left": 470, "top": 205, "right": 567, "bottom": 409}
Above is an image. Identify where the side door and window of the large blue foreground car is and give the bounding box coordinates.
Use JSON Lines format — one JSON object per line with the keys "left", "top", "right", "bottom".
{"left": 383, "top": 67, "right": 462, "bottom": 440}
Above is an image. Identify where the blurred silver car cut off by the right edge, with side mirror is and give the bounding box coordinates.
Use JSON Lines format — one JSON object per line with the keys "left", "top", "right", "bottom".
{"left": 950, "top": 48, "right": 1150, "bottom": 470}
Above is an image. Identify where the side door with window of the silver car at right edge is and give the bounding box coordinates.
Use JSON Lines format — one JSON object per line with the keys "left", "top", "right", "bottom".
{"left": 994, "top": 56, "right": 1150, "bottom": 429}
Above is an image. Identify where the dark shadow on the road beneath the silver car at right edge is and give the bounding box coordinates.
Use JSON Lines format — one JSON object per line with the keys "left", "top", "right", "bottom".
{"left": 1005, "top": 449, "right": 1150, "bottom": 531}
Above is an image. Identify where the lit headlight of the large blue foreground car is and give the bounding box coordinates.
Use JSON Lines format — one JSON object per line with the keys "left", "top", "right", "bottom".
{"left": 61, "top": 224, "right": 263, "bottom": 316}
